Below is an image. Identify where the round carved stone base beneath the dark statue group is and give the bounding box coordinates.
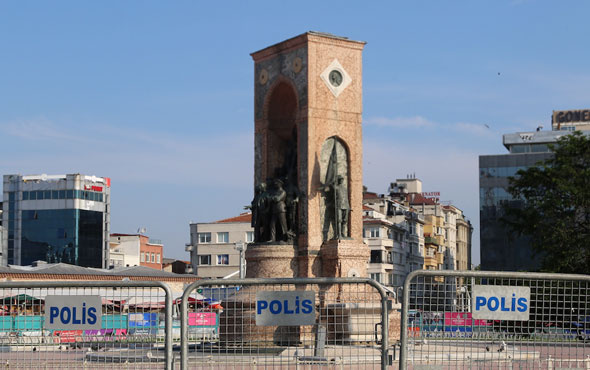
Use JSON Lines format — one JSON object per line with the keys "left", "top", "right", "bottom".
{"left": 246, "top": 243, "right": 297, "bottom": 278}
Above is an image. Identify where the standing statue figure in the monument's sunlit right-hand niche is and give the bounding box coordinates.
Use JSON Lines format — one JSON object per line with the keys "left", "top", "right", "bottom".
{"left": 324, "top": 176, "right": 350, "bottom": 239}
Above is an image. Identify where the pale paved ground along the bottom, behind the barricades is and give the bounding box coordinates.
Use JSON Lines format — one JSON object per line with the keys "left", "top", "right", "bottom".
{"left": 0, "top": 340, "right": 590, "bottom": 370}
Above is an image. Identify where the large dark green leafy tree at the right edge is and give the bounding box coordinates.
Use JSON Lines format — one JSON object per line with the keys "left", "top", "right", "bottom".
{"left": 503, "top": 131, "right": 590, "bottom": 274}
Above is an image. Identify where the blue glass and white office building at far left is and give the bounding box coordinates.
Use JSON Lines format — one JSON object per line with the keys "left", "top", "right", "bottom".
{"left": 0, "top": 174, "right": 111, "bottom": 268}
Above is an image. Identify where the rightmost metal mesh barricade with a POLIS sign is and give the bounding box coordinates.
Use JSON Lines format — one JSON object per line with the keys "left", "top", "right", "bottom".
{"left": 399, "top": 270, "right": 590, "bottom": 369}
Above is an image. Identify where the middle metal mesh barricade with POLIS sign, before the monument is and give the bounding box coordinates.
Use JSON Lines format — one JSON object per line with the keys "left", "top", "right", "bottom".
{"left": 181, "top": 278, "right": 389, "bottom": 369}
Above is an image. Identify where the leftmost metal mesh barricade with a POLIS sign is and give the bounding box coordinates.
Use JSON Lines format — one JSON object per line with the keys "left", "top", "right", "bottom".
{"left": 0, "top": 281, "right": 172, "bottom": 369}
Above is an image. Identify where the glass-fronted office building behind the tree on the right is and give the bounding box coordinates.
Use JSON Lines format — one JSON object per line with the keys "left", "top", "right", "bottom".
{"left": 479, "top": 110, "right": 590, "bottom": 271}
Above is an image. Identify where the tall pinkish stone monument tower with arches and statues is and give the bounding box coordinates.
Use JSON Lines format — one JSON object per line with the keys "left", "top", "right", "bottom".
{"left": 246, "top": 32, "right": 369, "bottom": 277}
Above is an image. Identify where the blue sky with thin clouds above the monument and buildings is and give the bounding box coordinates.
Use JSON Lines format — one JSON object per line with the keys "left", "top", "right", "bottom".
{"left": 0, "top": 0, "right": 590, "bottom": 262}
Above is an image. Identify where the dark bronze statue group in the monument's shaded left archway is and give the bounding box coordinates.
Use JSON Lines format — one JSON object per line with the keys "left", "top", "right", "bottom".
{"left": 249, "top": 177, "right": 299, "bottom": 243}
